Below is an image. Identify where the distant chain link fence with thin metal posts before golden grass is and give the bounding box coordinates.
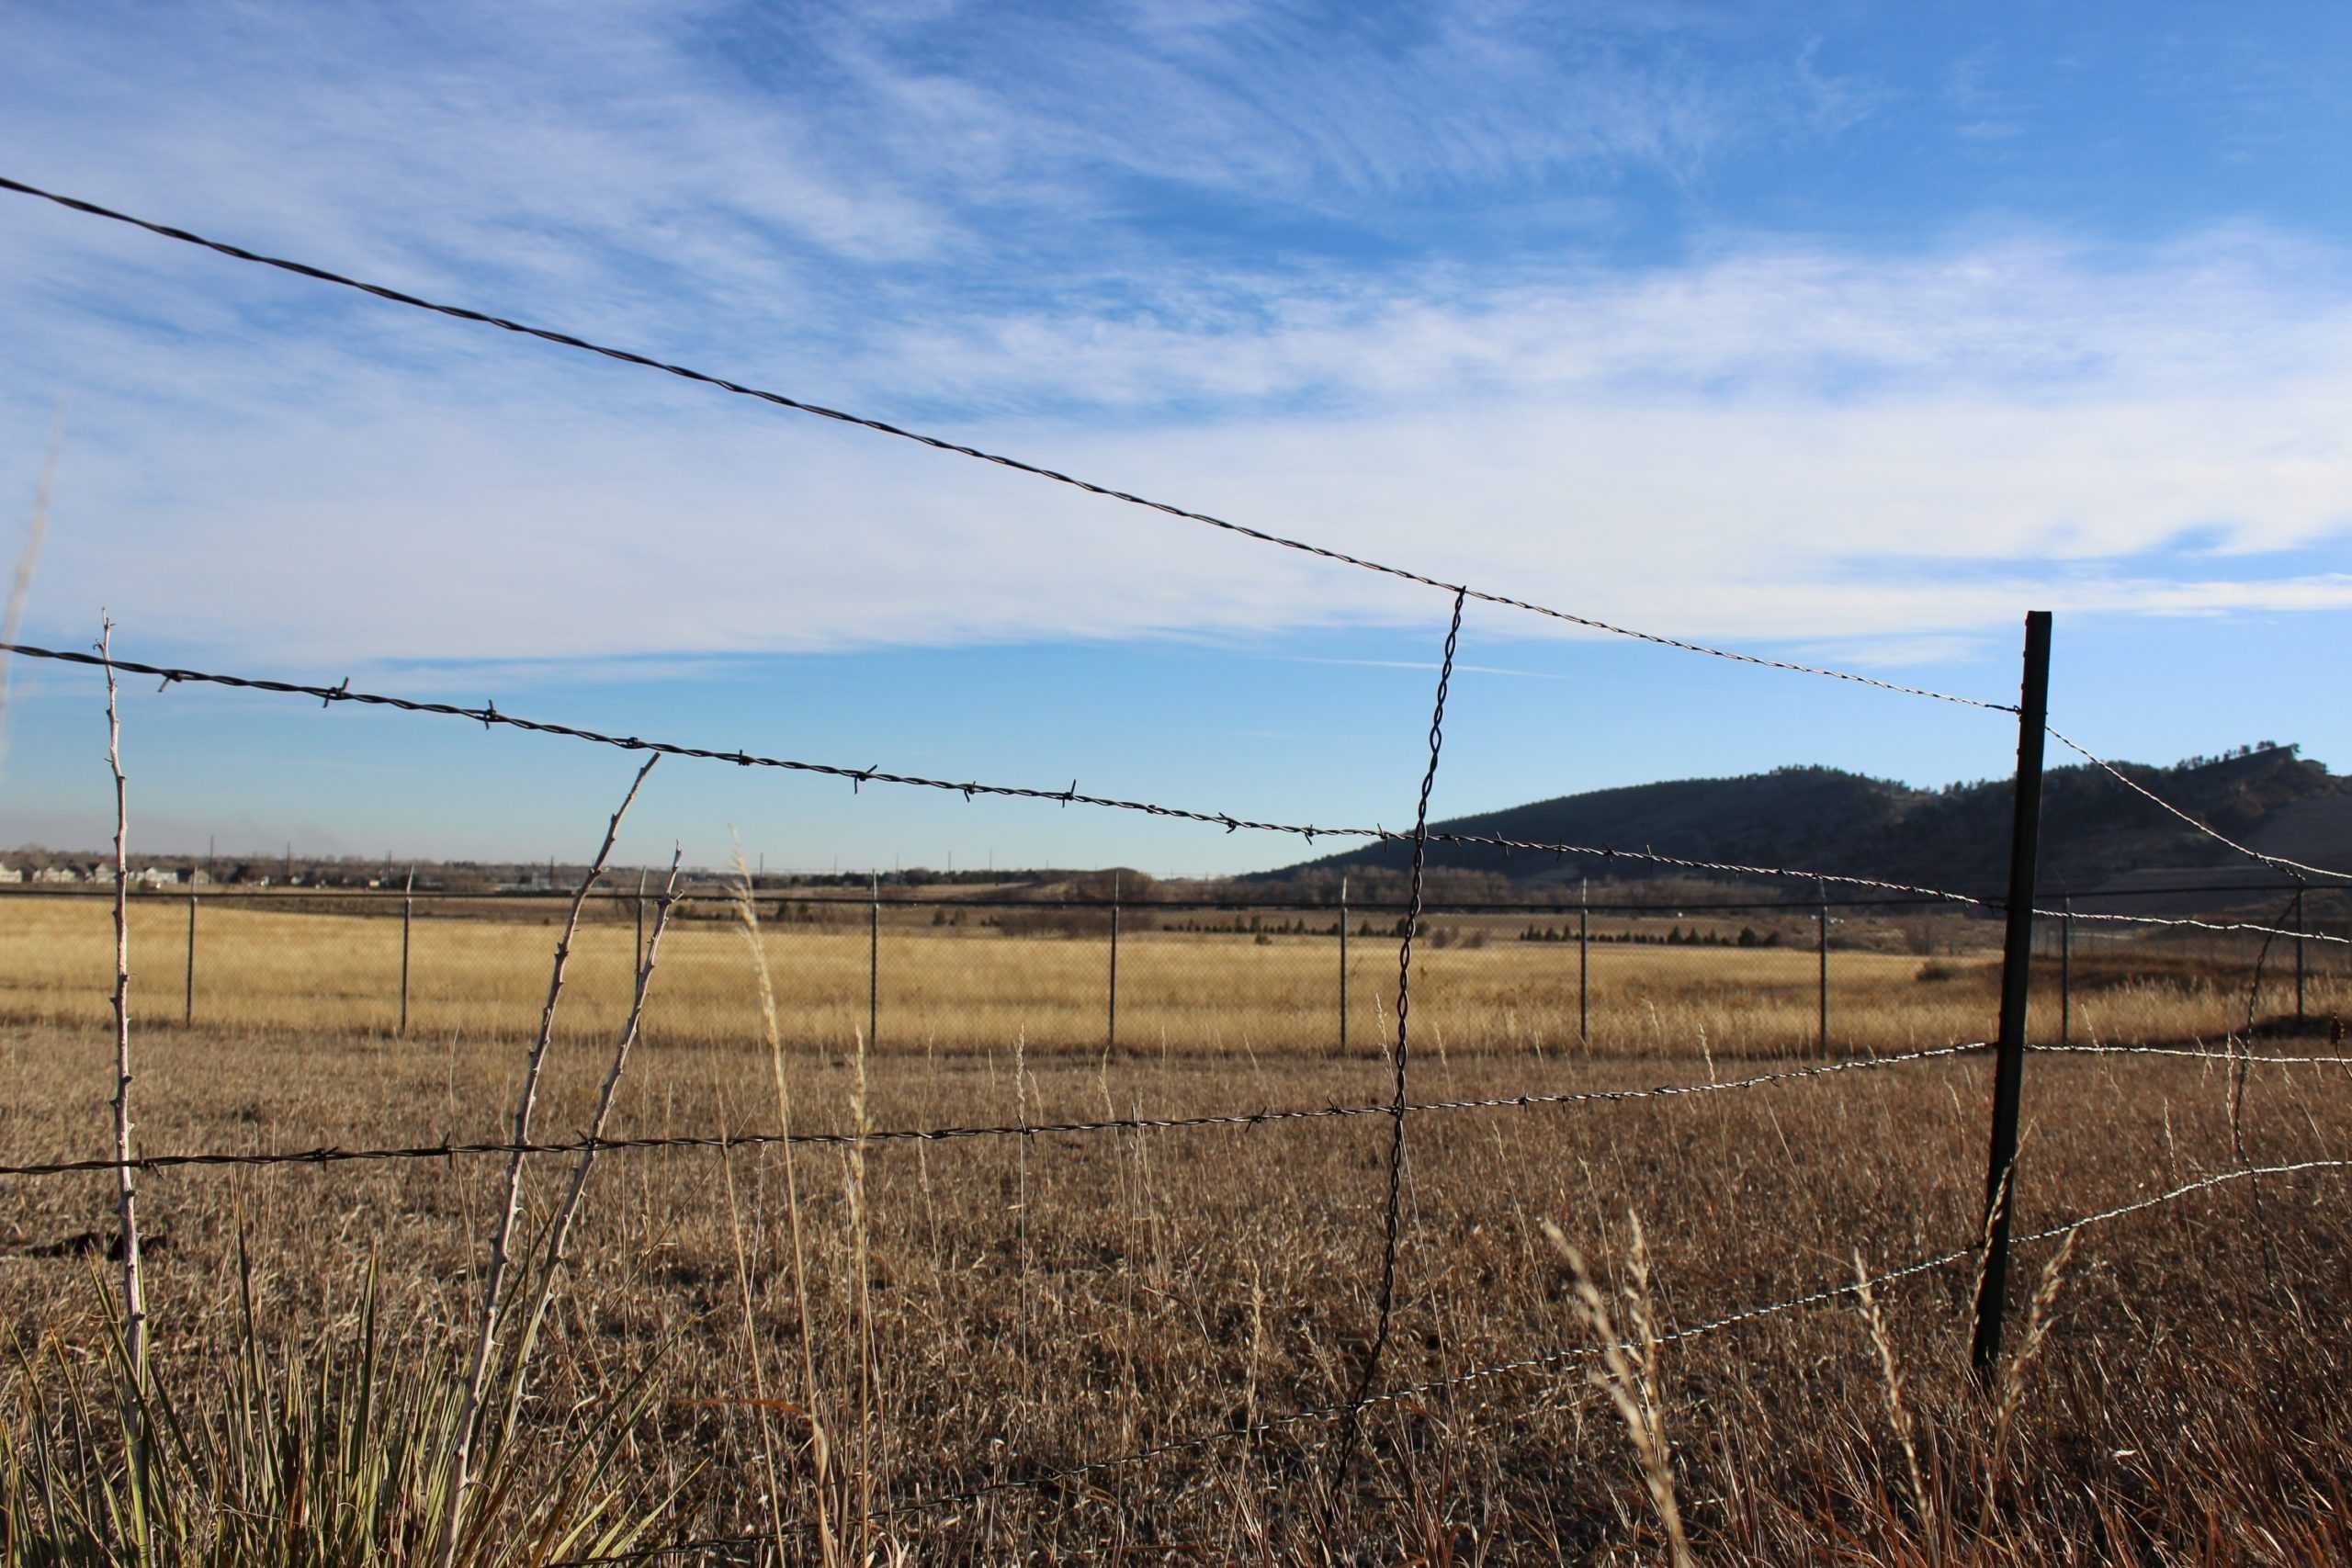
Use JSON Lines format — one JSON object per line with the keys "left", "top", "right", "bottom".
{"left": 0, "top": 888, "right": 2352, "bottom": 1058}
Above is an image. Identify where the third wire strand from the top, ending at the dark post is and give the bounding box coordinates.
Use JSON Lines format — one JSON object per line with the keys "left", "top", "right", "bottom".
{"left": 0, "top": 1042, "right": 1992, "bottom": 1178}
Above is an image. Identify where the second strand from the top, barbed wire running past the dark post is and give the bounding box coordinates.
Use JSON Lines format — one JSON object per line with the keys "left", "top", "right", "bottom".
{"left": 0, "top": 642, "right": 2352, "bottom": 945}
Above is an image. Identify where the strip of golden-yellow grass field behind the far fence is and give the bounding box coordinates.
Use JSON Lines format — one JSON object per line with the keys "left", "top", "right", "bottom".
{"left": 0, "top": 898, "right": 2352, "bottom": 1058}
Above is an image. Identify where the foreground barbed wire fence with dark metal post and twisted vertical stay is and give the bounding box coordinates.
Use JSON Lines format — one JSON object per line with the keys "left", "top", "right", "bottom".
{"left": 0, "top": 176, "right": 2352, "bottom": 1568}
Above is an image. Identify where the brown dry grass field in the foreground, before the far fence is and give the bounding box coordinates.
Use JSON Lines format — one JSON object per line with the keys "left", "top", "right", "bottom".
{"left": 0, "top": 944, "right": 2352, "bottom": 1563}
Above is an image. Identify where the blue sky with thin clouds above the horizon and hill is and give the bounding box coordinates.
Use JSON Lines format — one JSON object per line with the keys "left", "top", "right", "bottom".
{"left": 0, "top": 3, "right": 2352, "bottom": 872}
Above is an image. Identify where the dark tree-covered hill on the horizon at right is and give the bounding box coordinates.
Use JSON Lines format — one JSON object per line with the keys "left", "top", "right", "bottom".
{"left": 1261, "top": 745, "right": 2352, "bottom": 894}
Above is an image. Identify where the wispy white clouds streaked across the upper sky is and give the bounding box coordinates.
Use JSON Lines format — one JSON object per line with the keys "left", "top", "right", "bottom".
{"left": 0, "top": 5, "right": 2352, "bottom": 665}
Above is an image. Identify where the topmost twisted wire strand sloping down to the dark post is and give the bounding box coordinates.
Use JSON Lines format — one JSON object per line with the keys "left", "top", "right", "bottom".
{"left": 0, "top": 176, "right": 2016, "bottom": 712}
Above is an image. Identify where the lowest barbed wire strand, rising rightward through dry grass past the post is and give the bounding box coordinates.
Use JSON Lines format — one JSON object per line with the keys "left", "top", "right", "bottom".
{"left": 548, "top": 1159, "right": 2352, "bottom": 1568}
